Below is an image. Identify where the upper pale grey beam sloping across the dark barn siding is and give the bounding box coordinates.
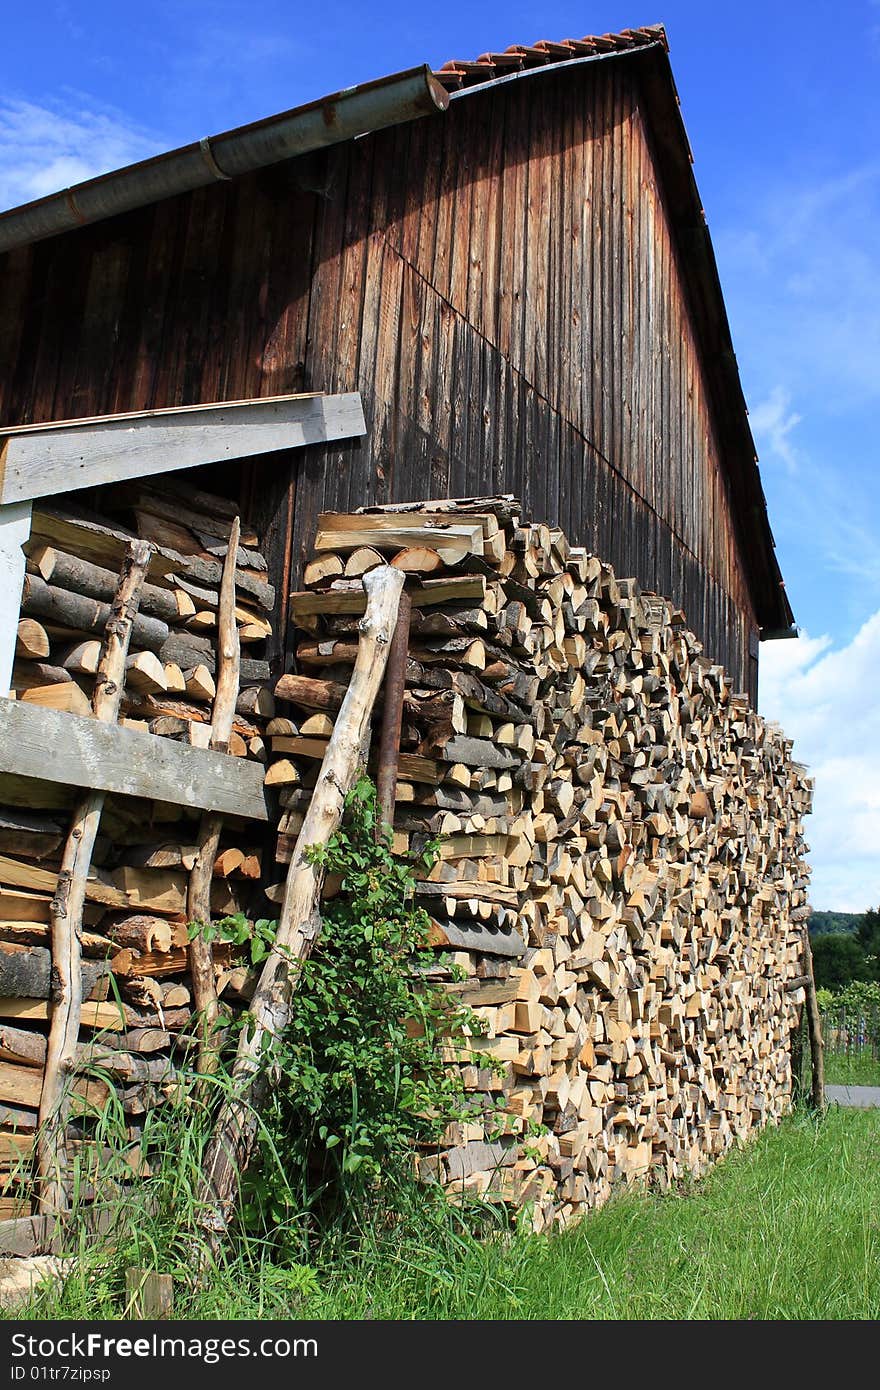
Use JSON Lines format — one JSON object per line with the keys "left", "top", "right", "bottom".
{"left": 0, "top": 392, "right": 366, "bottom": 503}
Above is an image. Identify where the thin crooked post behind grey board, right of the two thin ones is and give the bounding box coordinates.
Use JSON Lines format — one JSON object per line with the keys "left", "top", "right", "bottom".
{"left": 186, "top": 517, "right": 241, "bottom": 1073}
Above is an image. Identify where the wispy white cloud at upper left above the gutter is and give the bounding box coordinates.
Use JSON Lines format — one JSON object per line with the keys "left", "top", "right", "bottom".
{"left": 0, "top": 93, "right": 163, "bottom": 207}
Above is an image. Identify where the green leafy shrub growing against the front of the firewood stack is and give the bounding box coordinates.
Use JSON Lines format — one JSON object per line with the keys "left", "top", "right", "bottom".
{"left": 245, "top": 777, "right": 482, "bottom": 1251}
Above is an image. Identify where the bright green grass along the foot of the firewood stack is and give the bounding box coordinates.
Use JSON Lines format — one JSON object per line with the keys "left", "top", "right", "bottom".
{"left": 15, "top": 1109, "right": 880, "bottom": 1321}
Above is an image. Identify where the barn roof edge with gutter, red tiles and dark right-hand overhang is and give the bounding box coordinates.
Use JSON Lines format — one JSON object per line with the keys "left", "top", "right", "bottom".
{"left": 0, "top": 25, "right": 795, "bottom": 638}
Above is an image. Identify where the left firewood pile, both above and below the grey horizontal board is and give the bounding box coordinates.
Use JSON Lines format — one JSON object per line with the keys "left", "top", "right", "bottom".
{"left": 0, "top": 477, "right": 274, "bottom": 1216}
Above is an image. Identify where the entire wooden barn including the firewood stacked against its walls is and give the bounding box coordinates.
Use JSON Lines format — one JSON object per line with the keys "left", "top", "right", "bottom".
{"left": 0, "top": 28, "right": 809, "bottom": 1252}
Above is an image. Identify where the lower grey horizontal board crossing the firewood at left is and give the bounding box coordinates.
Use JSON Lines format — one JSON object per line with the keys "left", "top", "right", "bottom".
{"left": 0, "top": 699, "right": 267, "bottom": 820}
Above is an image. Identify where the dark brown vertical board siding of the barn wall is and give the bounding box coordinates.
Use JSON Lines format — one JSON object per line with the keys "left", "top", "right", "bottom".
{"left": 0, "top": 63, "right": 756, "bottom": 694}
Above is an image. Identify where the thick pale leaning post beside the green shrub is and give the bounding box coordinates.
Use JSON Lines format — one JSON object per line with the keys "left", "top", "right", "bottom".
{"left": 199, "top": 564, "right": 403, "bottom": 1252}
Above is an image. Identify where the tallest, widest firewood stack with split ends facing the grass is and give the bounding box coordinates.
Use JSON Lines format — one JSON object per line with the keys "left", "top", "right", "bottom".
{"left": 267, "top": 498, "right": 810, "bottom": 1225}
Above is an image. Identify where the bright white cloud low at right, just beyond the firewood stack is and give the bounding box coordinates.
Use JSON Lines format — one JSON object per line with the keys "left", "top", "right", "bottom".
{"left": 759, "top": 612, "right": 880, "bottom": 912}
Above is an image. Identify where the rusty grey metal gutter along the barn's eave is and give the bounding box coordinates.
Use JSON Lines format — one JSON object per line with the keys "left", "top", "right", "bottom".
{"left": 0, "top": 64, "right": 449, "bottom": 253}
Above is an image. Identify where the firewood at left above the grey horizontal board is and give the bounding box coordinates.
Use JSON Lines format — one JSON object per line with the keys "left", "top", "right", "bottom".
{"left": 13, "top": 478, "right": 275, "bottom": 759}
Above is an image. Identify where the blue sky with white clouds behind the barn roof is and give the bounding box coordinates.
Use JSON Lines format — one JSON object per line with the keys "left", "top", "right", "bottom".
{"left": 0, "top": 0, "right": 880, "bottom": 910}
